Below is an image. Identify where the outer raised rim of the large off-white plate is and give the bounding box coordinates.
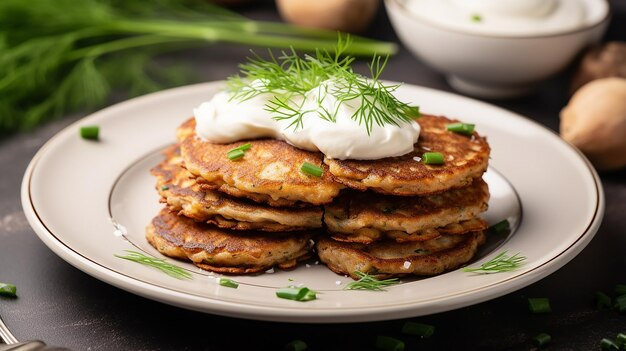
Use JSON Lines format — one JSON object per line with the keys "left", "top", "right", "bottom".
{"left": 21, "top": 81, "right": 605, "bottom": 323}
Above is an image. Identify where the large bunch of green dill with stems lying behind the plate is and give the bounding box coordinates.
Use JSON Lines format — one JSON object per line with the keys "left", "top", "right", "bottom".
{"left": 0, "top": 0, "right": 395, "bottom": 135}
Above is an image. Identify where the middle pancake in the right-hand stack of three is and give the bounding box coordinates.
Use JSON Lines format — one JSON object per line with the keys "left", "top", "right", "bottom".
{"left": 324, "top": 179, "right": 489, "bottom": 243}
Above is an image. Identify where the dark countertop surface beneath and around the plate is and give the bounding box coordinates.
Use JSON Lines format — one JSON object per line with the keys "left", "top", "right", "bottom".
{"left": 0, "top": 0, "right": 626, "bottom": 350}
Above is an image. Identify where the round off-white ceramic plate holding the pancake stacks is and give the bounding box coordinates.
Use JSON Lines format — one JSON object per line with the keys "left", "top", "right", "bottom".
{"left": 22, "top": 82, "right": 604, "bottom": 323}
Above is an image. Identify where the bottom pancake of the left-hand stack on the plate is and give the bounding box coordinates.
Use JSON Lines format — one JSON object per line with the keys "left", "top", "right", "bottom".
{"left": 146, "top": 209, "right": 314, "bottom": 274}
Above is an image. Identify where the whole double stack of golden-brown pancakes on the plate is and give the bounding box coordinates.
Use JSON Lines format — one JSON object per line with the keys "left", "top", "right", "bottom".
{"left": 147, "top": 115, "right": 490, "bottom": 278}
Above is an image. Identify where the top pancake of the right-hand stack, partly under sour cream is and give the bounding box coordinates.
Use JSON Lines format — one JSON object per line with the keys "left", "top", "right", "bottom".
{"left": 324, "top": 115, "right": 490, "bottom": 196}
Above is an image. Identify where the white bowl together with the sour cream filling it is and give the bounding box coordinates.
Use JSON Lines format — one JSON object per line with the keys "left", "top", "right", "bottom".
{"left": 385, "top": 0, "right": 611, "bottom": 98}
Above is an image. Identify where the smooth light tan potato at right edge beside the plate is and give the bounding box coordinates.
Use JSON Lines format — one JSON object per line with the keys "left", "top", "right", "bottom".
{"left": 560, "top": 78, "right": 626, "bottom": 170}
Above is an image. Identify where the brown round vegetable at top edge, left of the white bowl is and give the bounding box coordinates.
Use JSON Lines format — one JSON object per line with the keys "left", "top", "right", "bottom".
{"left": 276, "top": 0, "right": 380, "bottom": 33}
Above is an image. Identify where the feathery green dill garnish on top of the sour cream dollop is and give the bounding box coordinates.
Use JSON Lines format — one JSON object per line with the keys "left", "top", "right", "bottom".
{"left": 227, "top": 36, "right": 419, "bottom": 134}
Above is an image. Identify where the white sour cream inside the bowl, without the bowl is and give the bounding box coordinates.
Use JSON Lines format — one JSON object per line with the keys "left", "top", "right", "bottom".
{"left": 405, "top": 0, "right": 608, "bottom": 36}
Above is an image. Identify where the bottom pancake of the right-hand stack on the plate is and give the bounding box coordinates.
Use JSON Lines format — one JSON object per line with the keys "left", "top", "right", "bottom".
{"left": 316, "top": 231, "right": 485, "bottom": 280}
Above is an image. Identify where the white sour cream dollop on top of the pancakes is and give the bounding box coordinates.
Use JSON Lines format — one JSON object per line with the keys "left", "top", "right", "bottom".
{"left": 194, "top": 82, "right": 420, "bottom": 160}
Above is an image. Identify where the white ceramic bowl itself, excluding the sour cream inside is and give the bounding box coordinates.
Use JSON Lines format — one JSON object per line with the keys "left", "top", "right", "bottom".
{"left": 385, "top": 0, "right": 611, "bottom": 98}
